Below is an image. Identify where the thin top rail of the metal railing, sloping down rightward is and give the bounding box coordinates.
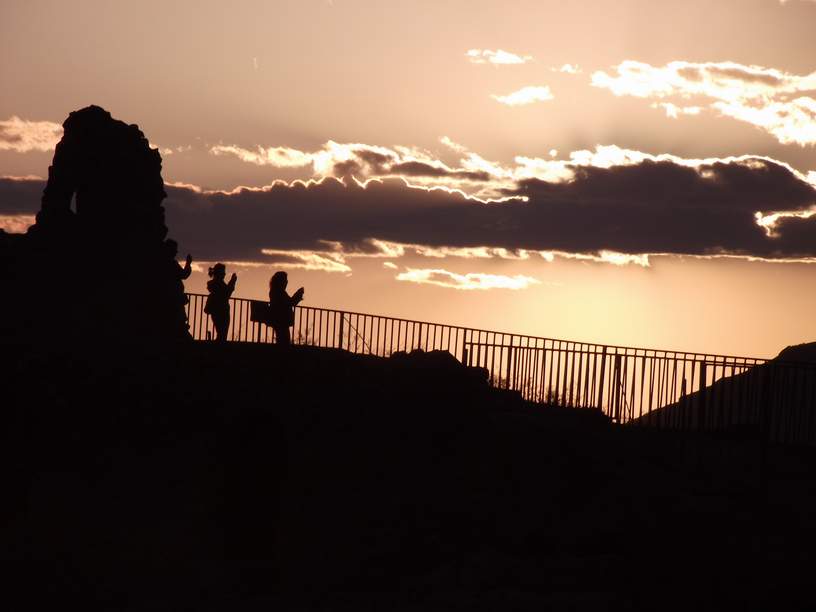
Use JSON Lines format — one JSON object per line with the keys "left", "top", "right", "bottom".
{"left": 187, "top": 292, "right": 768, "bottom": 364}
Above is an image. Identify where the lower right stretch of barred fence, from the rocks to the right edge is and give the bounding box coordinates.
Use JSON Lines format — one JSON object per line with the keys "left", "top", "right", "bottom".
{"left": 465, "top": 336, "right": 816, "bottom": 444}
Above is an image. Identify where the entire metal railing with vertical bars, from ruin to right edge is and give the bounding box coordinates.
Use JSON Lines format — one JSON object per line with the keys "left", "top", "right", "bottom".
{"left": 187, "top": 294, "right": 816, "bottom": 444}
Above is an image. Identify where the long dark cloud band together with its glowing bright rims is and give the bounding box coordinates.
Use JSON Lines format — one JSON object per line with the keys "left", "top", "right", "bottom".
{"left": 6, "top": 146, "right": 816, "bottom": 262}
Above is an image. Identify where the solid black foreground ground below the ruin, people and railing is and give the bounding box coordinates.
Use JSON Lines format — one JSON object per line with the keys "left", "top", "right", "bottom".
{"left": 0, "top": 344, "right": 816, "bottom": 611}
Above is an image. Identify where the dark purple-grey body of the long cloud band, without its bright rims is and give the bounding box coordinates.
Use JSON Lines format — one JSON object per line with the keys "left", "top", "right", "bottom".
{"left": 0, "top": 158, "right": 816, "bottom": 261}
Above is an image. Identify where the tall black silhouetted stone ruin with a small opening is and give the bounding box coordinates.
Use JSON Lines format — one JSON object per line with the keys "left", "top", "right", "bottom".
{"left": 0, "top": 106, "right": 189, "bottom": 346}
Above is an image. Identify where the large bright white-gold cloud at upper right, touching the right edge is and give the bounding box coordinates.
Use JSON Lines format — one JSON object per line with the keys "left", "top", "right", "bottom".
{"left": 592, "top": 60, "right": 816, "bottom": 145}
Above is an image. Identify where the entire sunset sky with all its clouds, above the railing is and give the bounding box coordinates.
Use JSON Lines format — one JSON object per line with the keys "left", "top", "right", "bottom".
{"left": 0, "top": 0, "right": 816, "bottom": 357}
